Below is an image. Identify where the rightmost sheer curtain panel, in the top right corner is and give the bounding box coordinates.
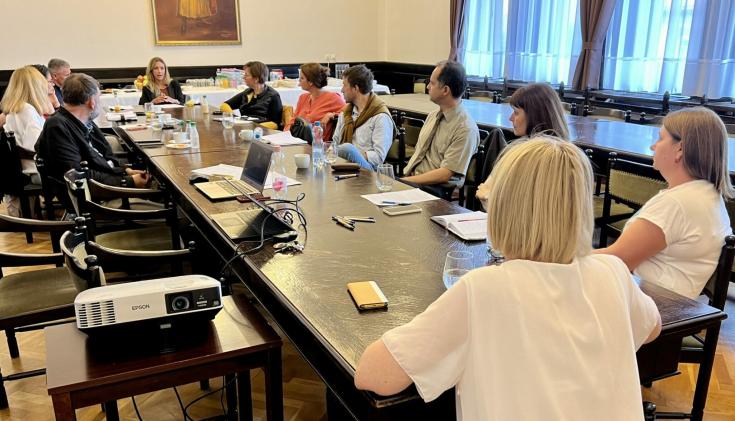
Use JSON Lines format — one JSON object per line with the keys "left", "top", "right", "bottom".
{"left": 682, "top": 0, "right": 735, "bottom": 99}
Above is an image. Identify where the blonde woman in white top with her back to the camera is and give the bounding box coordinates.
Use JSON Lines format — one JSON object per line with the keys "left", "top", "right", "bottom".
{"left": 355, "top": 136, "right": 661, "bottom": 421}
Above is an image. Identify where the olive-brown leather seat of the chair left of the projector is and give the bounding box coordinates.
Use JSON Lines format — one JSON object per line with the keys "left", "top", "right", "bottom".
{"left": 0, "top": 267, "right": 77, "bottom": 320}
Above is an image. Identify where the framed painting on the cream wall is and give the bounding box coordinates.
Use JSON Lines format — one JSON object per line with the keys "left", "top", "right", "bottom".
{"left": 151, "top": 0, "right": 242, "bottom": 45}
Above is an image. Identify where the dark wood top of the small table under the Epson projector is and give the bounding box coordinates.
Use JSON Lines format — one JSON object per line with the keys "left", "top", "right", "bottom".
{"left": 45, "top": 288, "right": 281, "bottom": 395}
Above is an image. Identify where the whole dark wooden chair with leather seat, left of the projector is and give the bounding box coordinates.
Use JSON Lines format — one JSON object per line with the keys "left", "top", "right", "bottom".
{"left": 0, "top": 214, "right": 77, "bottom": 409}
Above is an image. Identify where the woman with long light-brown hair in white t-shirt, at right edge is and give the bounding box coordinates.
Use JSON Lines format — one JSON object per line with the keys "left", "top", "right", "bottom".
{"left": 595, "top": 107, "right": 733, "bottom": 298}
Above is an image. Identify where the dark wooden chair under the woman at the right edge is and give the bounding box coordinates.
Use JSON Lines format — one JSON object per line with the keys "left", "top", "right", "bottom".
{"left": 643, "top": 235, "right": 735, "bottom": 420}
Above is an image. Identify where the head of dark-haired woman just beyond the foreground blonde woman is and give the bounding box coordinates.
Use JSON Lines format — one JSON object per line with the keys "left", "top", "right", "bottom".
{"left": 510, "top": 83, "right": 570, "bottom": 140}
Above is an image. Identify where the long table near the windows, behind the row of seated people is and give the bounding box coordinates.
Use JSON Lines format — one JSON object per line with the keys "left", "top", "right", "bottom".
{"left": 380, "top": 94, "right": 735, "bottom": 172}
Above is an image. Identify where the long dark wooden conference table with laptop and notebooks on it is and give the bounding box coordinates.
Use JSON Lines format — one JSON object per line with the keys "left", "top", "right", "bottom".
{"left": 116, "top": 109, "right": 726, "bottom": 420}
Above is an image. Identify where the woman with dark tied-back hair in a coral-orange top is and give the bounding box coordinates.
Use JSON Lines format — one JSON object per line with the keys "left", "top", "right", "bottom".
{"left": 283, "top": 63, "right": 345, "bottom": 140}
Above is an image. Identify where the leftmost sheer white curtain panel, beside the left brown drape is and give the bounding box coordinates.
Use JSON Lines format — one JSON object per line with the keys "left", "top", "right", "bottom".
{"left": 464, "top": 0, "right": 508, "bottom": 78}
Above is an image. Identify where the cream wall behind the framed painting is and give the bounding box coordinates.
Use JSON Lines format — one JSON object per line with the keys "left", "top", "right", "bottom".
{"left": 0, "top": 0, "right": 449, "bottom": 69}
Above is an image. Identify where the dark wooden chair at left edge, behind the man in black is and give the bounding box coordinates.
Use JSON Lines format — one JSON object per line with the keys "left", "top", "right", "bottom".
{"left": 0, "top": 130, "right": 42, "bottom": 240}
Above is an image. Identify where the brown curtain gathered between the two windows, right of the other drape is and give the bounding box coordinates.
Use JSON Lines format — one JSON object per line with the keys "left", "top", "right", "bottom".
{"left": 572, "top": 0, "right": 616, "bottom": 90}
